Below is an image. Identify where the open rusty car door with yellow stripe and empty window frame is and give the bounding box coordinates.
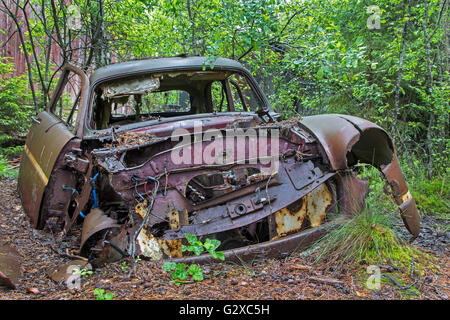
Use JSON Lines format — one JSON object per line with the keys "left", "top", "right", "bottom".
{"left": 18, "top": 65, "right": 89, "bottom": 227}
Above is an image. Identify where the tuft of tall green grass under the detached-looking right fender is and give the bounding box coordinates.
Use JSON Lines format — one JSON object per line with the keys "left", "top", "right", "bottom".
{"left": 315, "top": 166, "right": 431, "bottom": 270}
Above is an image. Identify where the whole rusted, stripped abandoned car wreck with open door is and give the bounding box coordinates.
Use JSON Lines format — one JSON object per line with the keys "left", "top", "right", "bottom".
{"left": 19, "top": 57, "right": 419, "bottom": 265}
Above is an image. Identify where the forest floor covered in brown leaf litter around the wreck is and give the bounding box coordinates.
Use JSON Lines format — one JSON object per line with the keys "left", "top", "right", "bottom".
{"left": 0, "top": 179, "right": 450, "bottom": 300}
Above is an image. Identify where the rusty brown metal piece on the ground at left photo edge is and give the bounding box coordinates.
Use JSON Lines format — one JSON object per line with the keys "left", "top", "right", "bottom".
{"left": 0, "top": 245, "right": 22, "bottom": 289}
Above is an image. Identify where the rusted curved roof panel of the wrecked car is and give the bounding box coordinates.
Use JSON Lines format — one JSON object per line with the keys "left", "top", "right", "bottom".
{"left": 90, "top": 56, "right": 246, "bottom": 84}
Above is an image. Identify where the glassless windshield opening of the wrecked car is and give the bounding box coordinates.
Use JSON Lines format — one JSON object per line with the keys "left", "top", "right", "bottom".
{"left": 91, "top": 71, "right": 263, "bottom": 130}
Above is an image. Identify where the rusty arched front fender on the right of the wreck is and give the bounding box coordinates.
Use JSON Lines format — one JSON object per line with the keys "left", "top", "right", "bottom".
{"left": 300, "top": 114, "right": 420, "bottom": 237}
